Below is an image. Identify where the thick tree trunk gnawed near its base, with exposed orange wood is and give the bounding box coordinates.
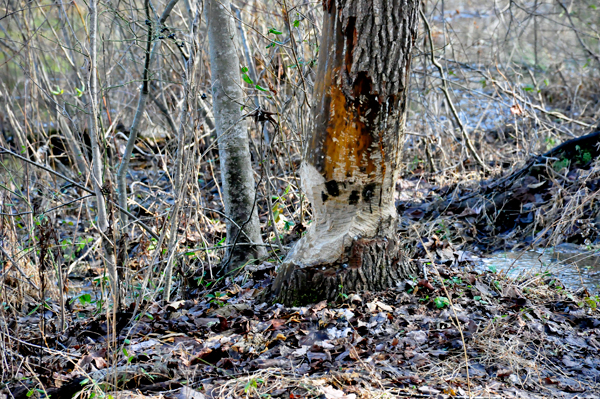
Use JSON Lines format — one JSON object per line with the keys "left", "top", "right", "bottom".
{"left": 273, "top": 0, "right": 419, "bottom": 305}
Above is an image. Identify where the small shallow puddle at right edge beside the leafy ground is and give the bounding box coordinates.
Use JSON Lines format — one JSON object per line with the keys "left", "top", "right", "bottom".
{"left": 479, "top": 245, "right": 600, "bottom": 294}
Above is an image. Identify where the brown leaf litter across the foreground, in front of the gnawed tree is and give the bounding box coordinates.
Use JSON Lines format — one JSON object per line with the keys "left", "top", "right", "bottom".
{"left": 2, "top": 252, "right": 600, "bottom": 399}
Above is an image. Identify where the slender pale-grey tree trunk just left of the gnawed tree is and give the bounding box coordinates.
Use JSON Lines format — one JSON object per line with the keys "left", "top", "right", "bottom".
{"left": 206, "top": 0, "right": 265, "bottom": 270}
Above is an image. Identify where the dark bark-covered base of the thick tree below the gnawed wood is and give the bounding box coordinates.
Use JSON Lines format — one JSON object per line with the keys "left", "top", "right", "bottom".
{"left": 275, "top": 237, "right": 416, "bottom": 306}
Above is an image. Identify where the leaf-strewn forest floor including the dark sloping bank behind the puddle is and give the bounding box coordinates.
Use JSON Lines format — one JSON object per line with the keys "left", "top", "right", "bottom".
{"left": 0, "top": 132, "right": 600, "bottom": 399}
